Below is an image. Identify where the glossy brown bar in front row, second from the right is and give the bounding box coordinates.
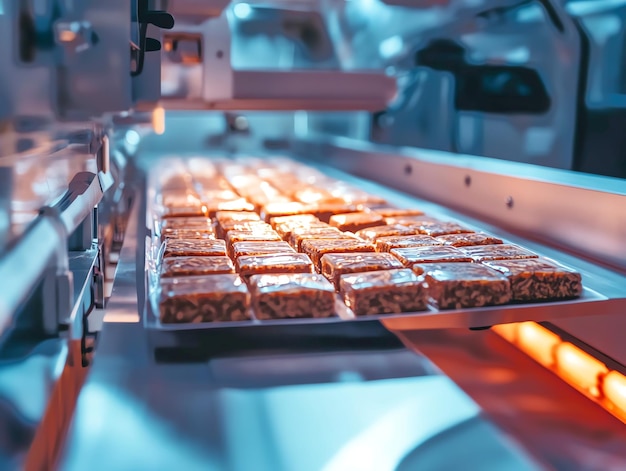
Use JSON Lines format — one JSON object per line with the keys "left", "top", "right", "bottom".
{"left": 415, "top": 263, "right": 511, "bottom": 309}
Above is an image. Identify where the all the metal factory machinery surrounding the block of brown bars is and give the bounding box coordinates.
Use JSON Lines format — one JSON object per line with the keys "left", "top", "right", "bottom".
{"left": 0, "top": 0, "right": 626, "bottom": 471}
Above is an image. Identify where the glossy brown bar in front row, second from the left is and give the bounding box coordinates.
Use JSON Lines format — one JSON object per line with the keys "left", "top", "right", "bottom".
{"left": 249, "top": 273, "right": 335, "bottom": 320}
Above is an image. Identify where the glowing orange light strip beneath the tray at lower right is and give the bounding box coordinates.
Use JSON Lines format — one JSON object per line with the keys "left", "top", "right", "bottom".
{"left": 493, "top": 322, "right": 626, "bottom": 423}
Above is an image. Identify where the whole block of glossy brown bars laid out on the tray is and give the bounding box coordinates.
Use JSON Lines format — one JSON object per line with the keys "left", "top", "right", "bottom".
{"left": 151, "top": 158, "right": 582, "bottom": 323}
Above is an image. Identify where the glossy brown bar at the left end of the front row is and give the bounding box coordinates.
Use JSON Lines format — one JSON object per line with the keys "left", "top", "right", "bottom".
{"left": 158, "top": 274, "right": 250, "bottom": 324}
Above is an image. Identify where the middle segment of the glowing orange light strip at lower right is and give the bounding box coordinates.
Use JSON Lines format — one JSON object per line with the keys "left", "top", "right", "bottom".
{"left": 556, "top": 342, "right": 609, "bottom": 397}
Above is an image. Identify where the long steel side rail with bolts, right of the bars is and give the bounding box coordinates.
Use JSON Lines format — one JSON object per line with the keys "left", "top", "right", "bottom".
{"left": 296, "top": 137, "right": 626, "bottom": 270}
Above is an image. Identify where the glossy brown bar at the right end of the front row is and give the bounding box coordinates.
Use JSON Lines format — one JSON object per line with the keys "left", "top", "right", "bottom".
{"left": 483, "top": 258, "right": 583, "bottom": 301}
